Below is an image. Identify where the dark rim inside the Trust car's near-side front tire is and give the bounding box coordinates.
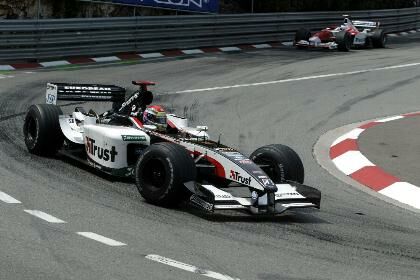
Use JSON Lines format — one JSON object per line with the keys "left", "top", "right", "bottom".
{"left": 142, "top": 158, "right": 167, "bottom": 190}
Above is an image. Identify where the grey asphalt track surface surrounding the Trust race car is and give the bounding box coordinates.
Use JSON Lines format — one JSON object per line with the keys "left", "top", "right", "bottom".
{"left": 0, "top": 35, "right": 420, "bottom": 280}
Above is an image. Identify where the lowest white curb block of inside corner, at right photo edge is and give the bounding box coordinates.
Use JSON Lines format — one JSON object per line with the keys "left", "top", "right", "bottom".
{"left": 379, "top": 182, "right": 420, "bottom": 209}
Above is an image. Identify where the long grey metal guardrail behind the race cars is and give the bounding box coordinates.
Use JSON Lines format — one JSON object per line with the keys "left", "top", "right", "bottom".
{"left": 0, "top": 8, "right": 420, "bottom": 61}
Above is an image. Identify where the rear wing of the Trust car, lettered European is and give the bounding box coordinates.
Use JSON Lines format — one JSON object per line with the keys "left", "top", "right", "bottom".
{"left": 45, "top": 83, "right": 126, "bottom": 108}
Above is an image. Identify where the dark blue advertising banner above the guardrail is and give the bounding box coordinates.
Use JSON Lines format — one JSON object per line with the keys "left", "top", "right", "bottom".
{"left": 112, "top": 0, "right": 219, "bottom": 13}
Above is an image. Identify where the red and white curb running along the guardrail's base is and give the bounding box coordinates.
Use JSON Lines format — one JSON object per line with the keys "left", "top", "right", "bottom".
{"left": 0, "top": 43, "right": 280, "bottom": 71}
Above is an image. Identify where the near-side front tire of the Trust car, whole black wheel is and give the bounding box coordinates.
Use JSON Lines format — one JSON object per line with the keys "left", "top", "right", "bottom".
{"left": 135, "top": 142, "right": 196, "bottom": 207}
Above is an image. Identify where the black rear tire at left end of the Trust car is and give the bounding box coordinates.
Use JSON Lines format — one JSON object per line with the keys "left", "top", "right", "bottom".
{"left": 23, "top": 104, "right": 64, "bottom": 156}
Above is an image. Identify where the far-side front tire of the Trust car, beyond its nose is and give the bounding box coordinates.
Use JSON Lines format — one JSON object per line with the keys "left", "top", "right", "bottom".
{"left": 250, "top": 144, "right": 305, "bottom": 184}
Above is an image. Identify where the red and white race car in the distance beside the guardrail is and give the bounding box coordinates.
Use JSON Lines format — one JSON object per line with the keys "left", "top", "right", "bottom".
{"left": 294, "top": 15, "right": 386, "bottom": 51}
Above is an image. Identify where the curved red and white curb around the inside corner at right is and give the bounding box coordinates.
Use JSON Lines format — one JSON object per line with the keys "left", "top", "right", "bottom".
{"left": 330, "top": 113, "right": 420, "bottom": 209}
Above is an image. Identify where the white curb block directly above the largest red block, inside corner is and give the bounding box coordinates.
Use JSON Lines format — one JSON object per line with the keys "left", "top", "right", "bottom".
{"left": 332, "top": 151, "right": 375, "bottom": 175}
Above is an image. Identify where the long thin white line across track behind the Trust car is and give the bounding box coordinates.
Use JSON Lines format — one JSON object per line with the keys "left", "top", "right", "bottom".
{"left": 166, "top": 62, "right": 420, "bottom": 94}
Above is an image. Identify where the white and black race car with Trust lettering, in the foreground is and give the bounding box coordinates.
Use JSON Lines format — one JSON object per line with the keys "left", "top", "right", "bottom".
{"left": 23, "top": 81, "right": 321, "bottom": 214}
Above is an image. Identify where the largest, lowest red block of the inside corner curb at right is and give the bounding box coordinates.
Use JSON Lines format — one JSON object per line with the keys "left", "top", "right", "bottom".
{"left": 350, "top": 166, "right": 400, "bottom": 191}
